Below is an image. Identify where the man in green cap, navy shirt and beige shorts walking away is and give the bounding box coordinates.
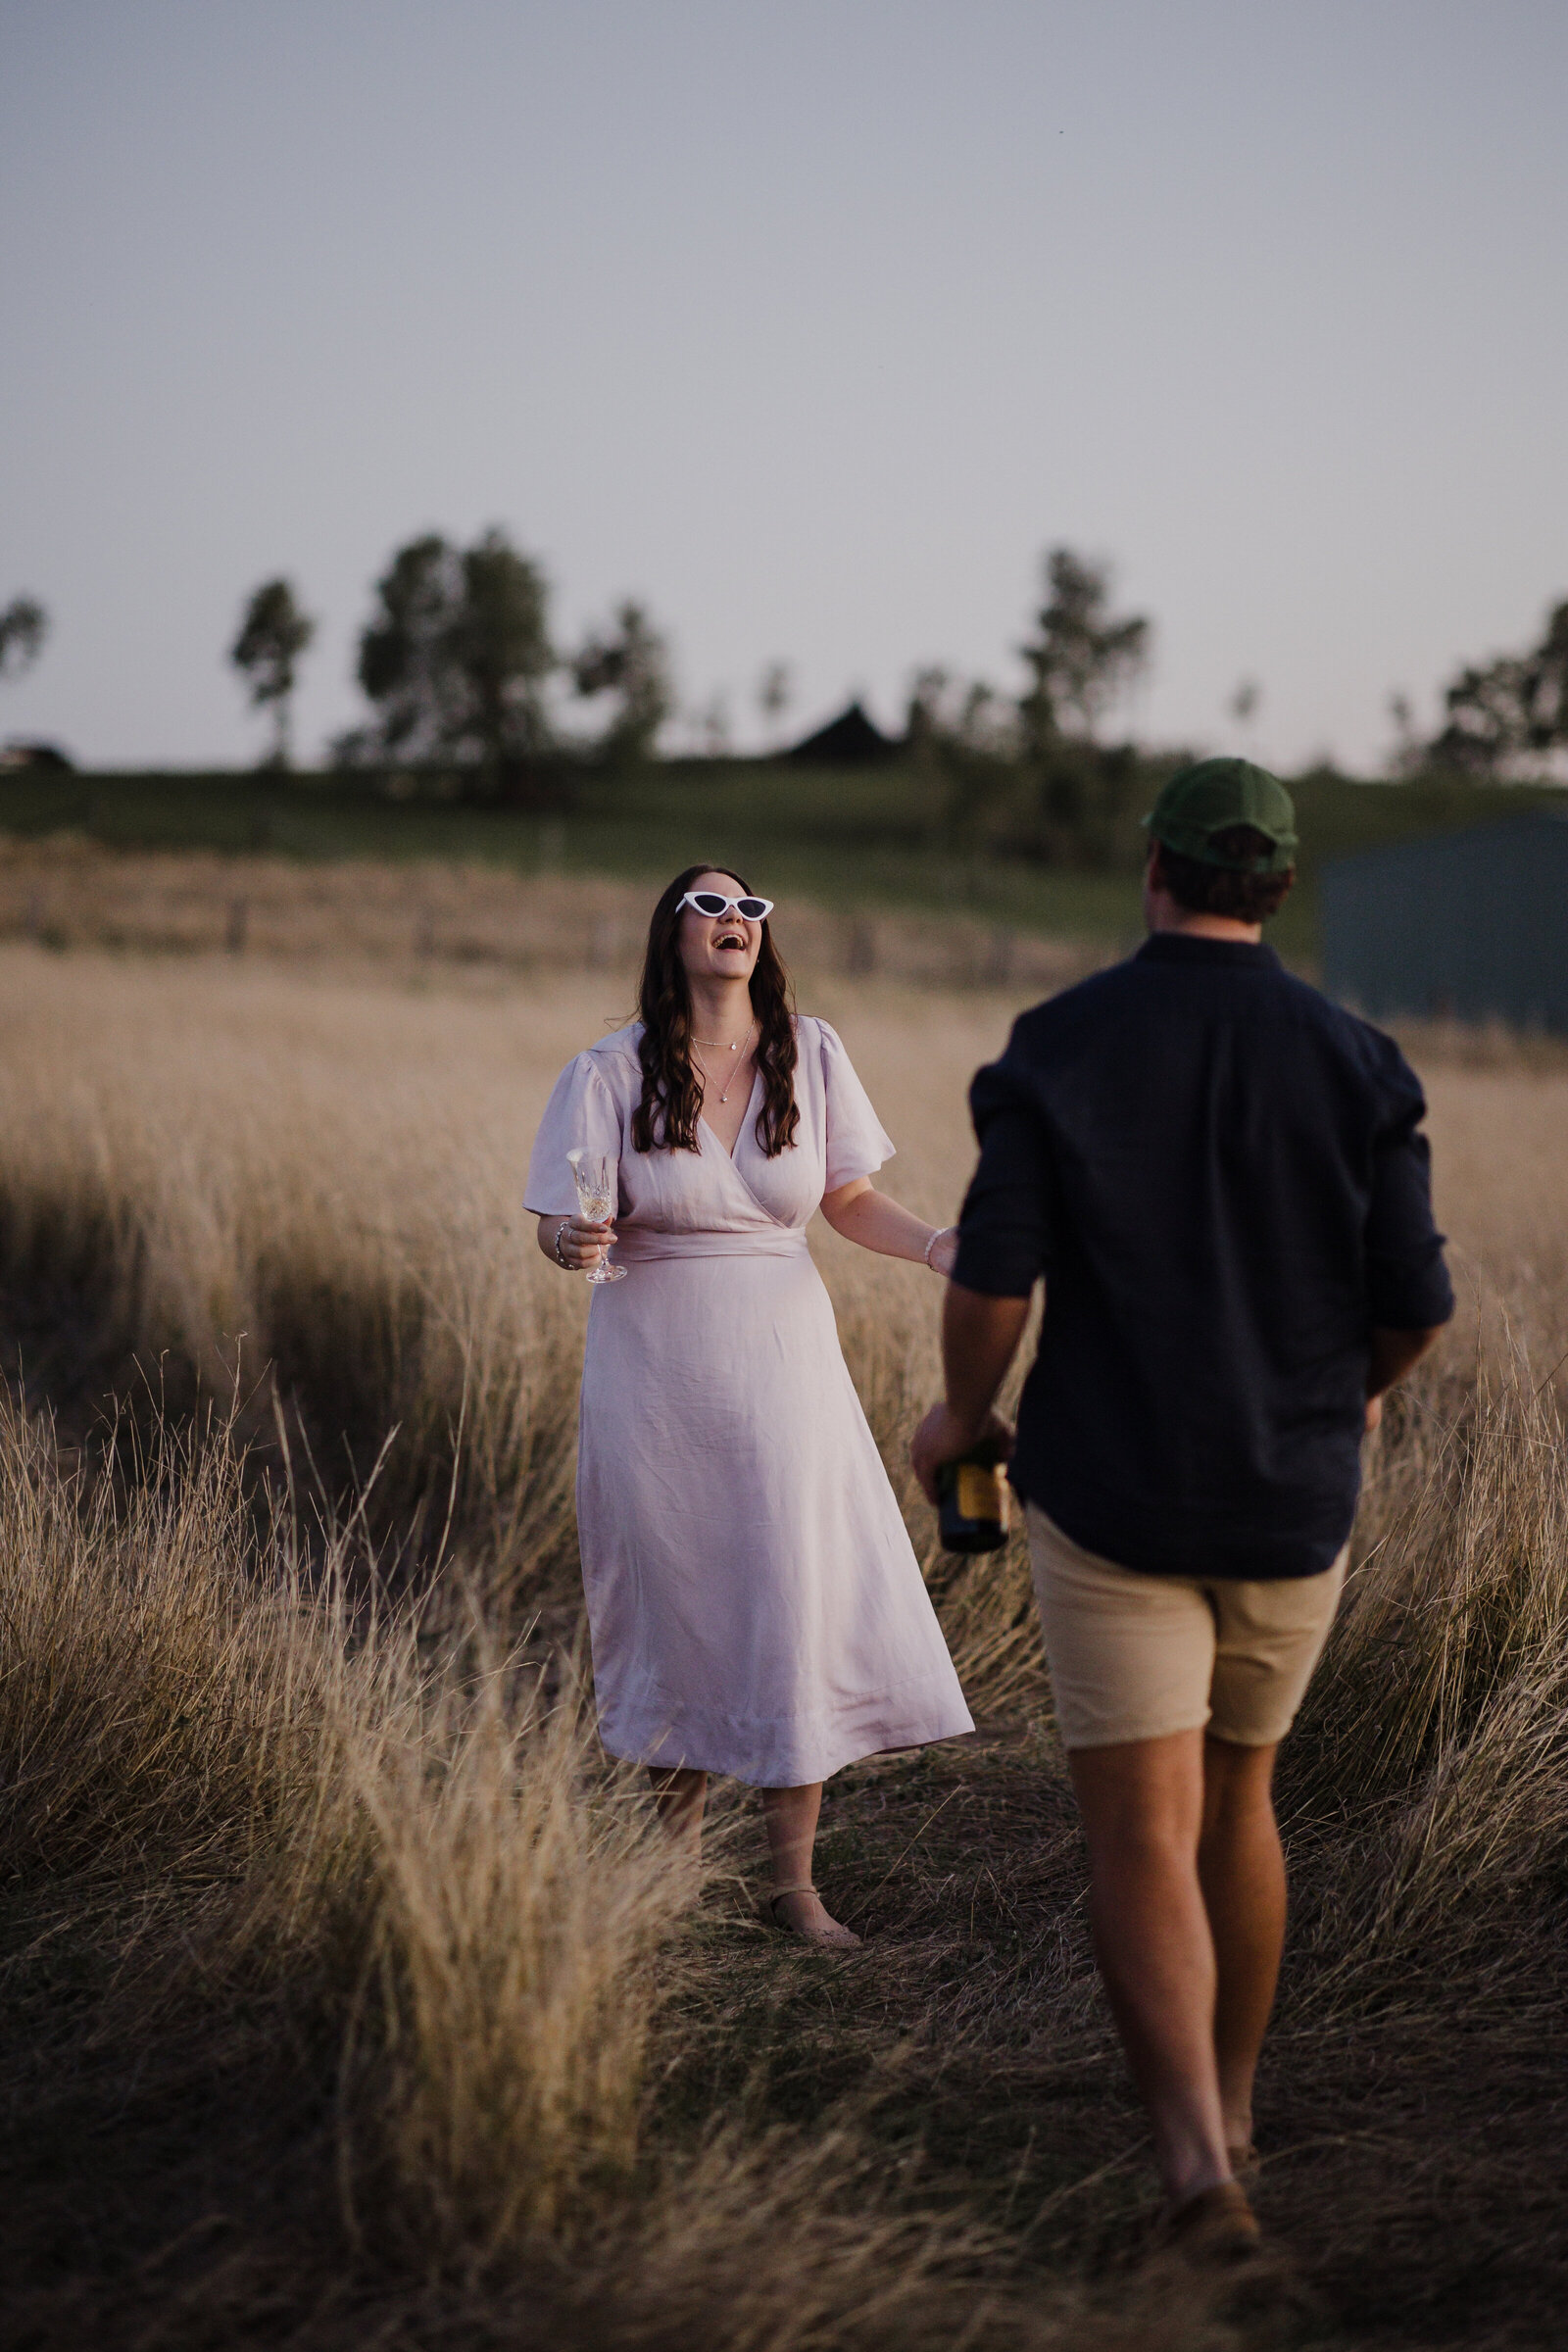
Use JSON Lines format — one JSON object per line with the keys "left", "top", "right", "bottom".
{"left": 914, "top": 760, "right": 1452, "bottom": 2258}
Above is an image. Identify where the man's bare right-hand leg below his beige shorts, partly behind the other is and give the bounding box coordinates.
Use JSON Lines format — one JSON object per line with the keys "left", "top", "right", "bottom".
{"left": 1199, "top": 1739, "right": 1286, "bottom": 2150}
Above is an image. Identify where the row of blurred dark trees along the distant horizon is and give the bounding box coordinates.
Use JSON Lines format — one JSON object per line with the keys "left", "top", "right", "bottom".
{"left": 0, "top": 527, "right": 1568, "bottom": 808}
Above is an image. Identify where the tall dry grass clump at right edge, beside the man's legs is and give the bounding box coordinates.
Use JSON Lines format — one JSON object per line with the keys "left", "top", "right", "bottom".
{"left": 1291, "top": 1346, "right": 1568, "bottom": 1997}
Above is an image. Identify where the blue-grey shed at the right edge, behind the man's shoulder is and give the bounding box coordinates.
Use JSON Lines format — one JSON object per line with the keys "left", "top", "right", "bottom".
{"left": 1319, "top": 809, "right": 1568, "bottom": 1033}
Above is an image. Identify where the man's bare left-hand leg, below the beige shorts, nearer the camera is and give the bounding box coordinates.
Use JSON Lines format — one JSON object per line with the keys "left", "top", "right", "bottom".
{"left": 1067, "top": 1731, "right": 1230, "bottom": 2204}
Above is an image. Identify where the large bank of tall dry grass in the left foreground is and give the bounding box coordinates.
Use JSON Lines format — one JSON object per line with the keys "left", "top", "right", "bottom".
{"left": 0, "top": 1399, "right": 694, "bottom": 2253}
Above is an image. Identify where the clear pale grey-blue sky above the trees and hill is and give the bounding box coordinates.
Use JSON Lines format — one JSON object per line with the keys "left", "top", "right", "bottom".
{"left": 0, "top": 0, "right": 1568, "bottom": 766}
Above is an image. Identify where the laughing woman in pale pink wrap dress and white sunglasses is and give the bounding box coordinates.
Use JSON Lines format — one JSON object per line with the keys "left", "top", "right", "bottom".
{"left": 526, "top": 865, "right": 973, "bottom": 1945}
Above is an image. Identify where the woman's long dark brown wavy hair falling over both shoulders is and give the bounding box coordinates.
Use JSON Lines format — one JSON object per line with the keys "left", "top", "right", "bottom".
{"left": 632, "top": 858, "right": 800, "bottom": 1159}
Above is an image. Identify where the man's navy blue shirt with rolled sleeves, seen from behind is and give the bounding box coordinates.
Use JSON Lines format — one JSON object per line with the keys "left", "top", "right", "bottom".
{"left": 953, "top": 931, "right": 1452, "bottom": 1578}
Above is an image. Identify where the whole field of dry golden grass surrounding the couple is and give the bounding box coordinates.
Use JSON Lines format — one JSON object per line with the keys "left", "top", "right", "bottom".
{"left": 0, "top": 875, "right": 1568, "bottom": 2352}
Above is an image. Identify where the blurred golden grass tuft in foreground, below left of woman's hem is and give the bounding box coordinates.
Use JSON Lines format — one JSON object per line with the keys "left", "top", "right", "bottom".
{"left": 346, "top": 1630, "right": 696, "bottom": 2265}
